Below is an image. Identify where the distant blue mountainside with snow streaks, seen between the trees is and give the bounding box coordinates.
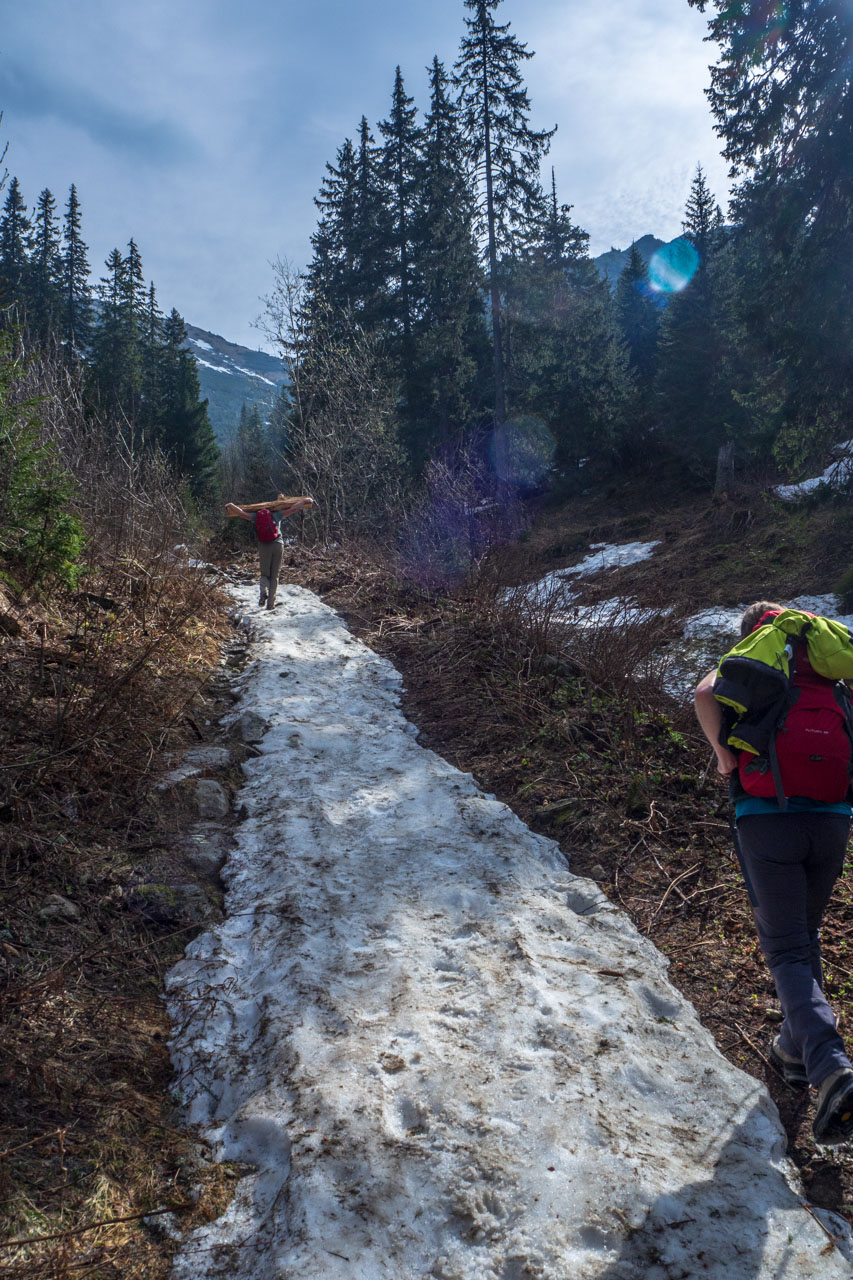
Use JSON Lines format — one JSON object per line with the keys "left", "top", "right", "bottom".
{"left": 187, "top": 324, "right": 287, "bottom": 444}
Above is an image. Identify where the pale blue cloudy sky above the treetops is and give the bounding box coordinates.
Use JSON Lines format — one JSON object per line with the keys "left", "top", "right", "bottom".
{"left": 0, "top": 0, "right": 727, "bottom": 347}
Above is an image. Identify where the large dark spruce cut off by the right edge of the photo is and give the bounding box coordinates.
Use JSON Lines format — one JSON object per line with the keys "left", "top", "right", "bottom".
{"left": 690, "top": 0, "right": 853, "bottom": 467}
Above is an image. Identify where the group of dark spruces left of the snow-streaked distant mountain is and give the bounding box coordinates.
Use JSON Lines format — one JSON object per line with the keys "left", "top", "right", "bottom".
{"left": 0, "top": 177, "right": 220, "bottom": 576}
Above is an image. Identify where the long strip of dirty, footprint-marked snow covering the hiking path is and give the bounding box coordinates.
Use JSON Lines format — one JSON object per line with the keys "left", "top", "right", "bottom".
{"left": 169, "top": 588, "right": 853, "bottom": 1280}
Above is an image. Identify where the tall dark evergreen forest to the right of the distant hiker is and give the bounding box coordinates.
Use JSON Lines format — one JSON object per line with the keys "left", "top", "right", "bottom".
{"left": 240, "top": 0, "right": 853, "bottom": 537}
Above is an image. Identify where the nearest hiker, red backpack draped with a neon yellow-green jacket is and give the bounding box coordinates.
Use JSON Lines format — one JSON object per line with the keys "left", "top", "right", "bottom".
{"left": 694, "top": 600, "right": 853, "bottom": 1146}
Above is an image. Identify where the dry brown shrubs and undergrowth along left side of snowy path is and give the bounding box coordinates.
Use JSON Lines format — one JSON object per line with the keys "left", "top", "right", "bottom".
{"left": 0, "top": 345, "right": 227, "bottom": 1280}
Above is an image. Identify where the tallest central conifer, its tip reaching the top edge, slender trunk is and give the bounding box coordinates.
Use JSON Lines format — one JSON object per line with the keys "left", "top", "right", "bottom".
{"left": 456, "top": 0, "right": 555, "bottom": 424}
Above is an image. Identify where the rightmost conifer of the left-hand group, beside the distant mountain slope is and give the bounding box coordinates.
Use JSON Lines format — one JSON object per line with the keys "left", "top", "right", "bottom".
{"left": 159, "top": 307, "right": 219, "bottom": 500}
